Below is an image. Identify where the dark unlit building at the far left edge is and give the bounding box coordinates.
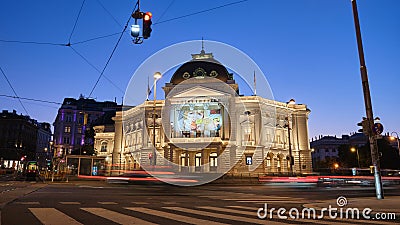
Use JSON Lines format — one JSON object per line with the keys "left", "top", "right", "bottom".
{"left": 0, "top": 110, "right": 51, "bottom": 169}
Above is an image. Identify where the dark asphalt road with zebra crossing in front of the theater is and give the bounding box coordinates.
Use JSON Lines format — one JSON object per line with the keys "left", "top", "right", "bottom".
{"left": 0, "top": 181, "right": 400, "bottom": 225}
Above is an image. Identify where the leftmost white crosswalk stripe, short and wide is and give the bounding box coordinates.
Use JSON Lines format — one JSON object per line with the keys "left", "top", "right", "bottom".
{"left": 28, "top": 208, "right": 83, "bottom": 225}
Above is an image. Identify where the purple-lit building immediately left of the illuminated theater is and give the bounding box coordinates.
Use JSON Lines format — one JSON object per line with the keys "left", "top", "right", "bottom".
{"left": 53, "top": 96, "right": 117, "bottom": 157}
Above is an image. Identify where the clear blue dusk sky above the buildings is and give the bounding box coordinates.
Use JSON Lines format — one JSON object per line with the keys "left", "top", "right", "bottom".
{"left": 0, "top": 0, "right": 400, "bottom": 139}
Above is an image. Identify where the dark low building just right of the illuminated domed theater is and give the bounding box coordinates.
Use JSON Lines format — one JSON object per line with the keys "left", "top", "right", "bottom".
{"left": 310, "top": 133, "right": 368, "bottom": 165}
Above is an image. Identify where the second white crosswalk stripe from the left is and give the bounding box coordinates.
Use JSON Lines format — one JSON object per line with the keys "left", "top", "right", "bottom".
{"left": 81, "top": 208, "right": 155, "bottom": 225}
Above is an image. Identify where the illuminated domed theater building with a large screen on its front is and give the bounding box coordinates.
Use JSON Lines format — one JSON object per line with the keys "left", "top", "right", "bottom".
{"left": 108, "top": 50, "right": 312, "bottom": 175}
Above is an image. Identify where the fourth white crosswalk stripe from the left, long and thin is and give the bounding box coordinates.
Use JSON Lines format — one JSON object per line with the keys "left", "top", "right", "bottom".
{"left": 163, "top": 207, "right": 282, "bottom": 225}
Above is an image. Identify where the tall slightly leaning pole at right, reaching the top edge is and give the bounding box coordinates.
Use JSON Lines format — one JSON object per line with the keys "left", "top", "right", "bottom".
{"left": 351, "top": 0, "right": 384, "bottom": 199}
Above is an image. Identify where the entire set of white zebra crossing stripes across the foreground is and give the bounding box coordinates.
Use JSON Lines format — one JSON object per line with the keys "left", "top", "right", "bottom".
{"left": 28, "top": 206, "right": 395, "bottom": 225}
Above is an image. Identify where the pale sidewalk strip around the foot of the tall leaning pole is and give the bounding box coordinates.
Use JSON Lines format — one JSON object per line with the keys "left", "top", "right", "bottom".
{"left": 303, "top": 196, "right": 400, "bottom": 214}
